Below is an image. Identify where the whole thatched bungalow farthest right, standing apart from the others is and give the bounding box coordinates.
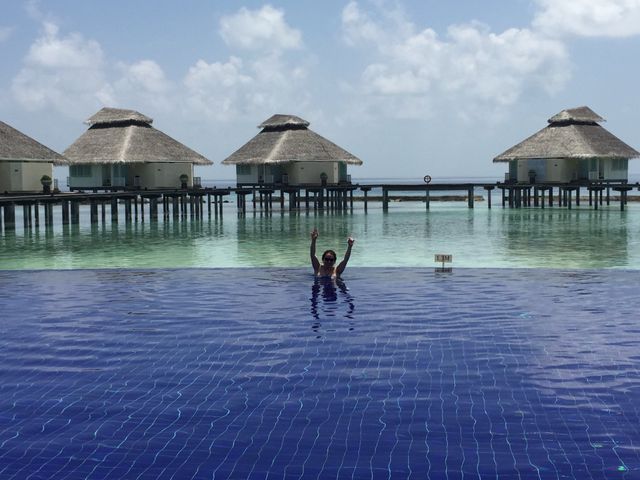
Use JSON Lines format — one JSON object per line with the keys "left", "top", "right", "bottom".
{"left": 493, "top": 107, "right": 640, "bottom": 183}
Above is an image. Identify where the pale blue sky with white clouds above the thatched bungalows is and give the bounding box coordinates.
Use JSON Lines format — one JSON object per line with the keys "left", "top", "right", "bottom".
{"left": 0, "top": 0, "right": 640, "bottom": 181}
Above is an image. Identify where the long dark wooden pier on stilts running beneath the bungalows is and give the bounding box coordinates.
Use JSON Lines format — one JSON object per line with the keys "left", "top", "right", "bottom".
{"left": 0, "top": 182, "right": 640, "bottom": 232}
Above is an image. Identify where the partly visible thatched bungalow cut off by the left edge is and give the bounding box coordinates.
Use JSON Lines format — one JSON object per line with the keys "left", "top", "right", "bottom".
{"left": 0, "top": 121, "right": 66, "bottom": 193}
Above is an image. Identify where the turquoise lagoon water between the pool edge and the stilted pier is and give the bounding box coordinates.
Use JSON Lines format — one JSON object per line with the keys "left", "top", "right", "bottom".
{"left": 0, "top": 178, "right": 640, "bottom": 269}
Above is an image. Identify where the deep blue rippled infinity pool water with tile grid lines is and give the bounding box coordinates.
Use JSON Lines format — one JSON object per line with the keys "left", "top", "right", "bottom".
{"left": 0, "top": 267, "right": 640, "bottom": 479}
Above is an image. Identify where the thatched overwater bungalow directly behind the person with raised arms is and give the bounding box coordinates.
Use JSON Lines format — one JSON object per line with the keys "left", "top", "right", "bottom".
{"left": 222, "top": 115, "right": 362, "bottom": 186}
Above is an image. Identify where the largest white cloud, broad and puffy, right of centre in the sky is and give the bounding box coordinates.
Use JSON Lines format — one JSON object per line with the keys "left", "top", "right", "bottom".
{"left": 342, "top": 2, "right": 569, "bottom": 116}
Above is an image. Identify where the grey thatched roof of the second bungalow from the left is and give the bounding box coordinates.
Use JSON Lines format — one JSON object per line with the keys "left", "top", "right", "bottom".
{"left": 64, "top": 108, "right": 213, "bottom": 165}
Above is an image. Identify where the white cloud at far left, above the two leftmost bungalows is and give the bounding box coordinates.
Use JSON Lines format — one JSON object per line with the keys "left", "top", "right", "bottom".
{"left": 12, "top": 22, "right": 111, "bottom": 116}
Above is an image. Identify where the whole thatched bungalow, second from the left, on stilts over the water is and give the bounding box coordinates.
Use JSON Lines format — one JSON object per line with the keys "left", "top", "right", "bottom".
{"left": 64, "top": 108, "right": 213, "bottom": 190}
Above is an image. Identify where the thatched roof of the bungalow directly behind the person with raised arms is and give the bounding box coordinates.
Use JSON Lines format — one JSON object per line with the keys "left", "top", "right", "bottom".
{"left": 222, "top": 115, "right": 362, "bottom": 165}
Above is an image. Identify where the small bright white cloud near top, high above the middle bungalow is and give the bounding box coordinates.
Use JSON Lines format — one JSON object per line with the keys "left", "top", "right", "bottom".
{"left": 220, "top": 5, "right": 302, "bottom": 51}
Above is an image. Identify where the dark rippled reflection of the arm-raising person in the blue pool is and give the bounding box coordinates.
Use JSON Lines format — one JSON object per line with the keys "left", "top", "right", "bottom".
{"left": 309, "top": 277, "right": 356, "bottom": 337}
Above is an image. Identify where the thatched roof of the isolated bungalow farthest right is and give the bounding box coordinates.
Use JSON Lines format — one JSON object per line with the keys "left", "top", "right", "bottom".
{"left": 493, "top": 107, "right": 640, "bottom": 162}
